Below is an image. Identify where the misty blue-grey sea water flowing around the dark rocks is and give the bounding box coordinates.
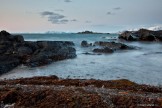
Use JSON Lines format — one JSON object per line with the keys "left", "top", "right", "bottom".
{"left": 0, "top": 34, "right": 162, "bottom": 85}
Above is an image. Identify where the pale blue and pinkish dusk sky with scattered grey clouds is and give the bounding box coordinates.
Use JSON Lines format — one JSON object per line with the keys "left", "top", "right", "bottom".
{"left": 0, "top": 0, "right": 162, "bottom": 33}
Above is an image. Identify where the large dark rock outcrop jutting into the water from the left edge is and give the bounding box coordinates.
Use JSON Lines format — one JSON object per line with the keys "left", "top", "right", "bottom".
{"left": 0, "top": 31, "right": 76, "bottom": 75}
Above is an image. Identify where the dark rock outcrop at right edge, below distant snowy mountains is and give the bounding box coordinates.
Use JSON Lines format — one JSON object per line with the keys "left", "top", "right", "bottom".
{"left": 119, "top": 29, "right": 162, "bottom": 41}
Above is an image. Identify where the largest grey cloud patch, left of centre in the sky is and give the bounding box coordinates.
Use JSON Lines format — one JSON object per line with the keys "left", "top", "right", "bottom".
{"left": 41, "top": 11, "right": 77, "bottom": 24}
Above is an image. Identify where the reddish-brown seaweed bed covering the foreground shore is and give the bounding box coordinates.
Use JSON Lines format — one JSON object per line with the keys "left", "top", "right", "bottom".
{"left": 0, "top": 76, "right": 162, "bottom": 108}
